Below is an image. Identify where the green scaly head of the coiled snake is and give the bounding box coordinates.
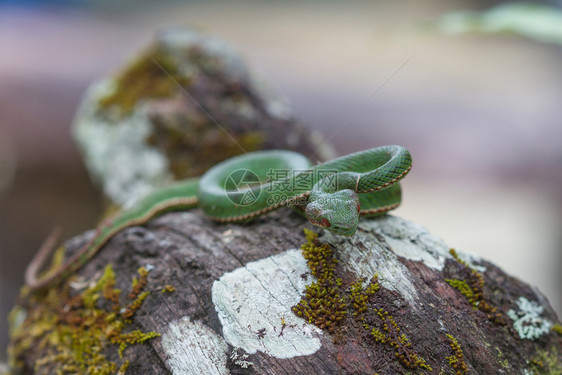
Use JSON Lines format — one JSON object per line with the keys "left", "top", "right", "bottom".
{"left": 305, "top": 189, "right": 359, "bottom": 236}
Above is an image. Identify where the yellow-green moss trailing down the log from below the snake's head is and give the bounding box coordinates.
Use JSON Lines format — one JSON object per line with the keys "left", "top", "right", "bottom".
{"left": 292, "top": 229, "right": 431, "bottom": 371}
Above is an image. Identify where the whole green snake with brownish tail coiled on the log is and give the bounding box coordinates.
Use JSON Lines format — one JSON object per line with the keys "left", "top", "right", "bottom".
{"left": 25, "top": 146, "right": 412, "bottom": 290}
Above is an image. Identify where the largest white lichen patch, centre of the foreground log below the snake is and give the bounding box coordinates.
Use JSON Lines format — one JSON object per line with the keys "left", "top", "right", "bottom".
{"left": 212, "top": 249, "right": 322, "bottom": 358}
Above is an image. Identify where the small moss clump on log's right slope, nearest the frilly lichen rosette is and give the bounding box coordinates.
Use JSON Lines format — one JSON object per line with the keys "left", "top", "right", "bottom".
{"left": 445, "top": 249, "right": 506, "bottom": 325}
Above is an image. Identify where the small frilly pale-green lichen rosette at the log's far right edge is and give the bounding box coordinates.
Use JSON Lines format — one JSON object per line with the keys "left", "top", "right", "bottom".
{"left": 507, "top": 297, "right": 552, "bottom": 340}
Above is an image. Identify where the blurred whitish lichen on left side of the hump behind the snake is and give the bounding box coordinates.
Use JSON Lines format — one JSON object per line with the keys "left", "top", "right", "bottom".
{"left": 73, "top": 79, "right": 172, "bottom": 208}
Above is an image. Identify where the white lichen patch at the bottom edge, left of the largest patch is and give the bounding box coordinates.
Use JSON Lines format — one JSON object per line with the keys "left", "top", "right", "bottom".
{"left": 162, "top": 316, "right": 230, "bottom": 375}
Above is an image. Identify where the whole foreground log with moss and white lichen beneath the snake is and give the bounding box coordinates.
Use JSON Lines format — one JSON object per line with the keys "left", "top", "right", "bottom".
{"left": 6, "top": 209, "right": 562, "bottom": 374}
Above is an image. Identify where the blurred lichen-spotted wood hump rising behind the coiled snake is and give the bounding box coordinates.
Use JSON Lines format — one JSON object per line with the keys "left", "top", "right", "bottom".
{"left": 73, "top": 28, "right": 334, "bottom": 206}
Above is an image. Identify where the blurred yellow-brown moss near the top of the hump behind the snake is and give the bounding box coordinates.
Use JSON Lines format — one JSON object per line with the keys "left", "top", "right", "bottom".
{"left": 98, "top": 47, "right": 190, "bottom": 116}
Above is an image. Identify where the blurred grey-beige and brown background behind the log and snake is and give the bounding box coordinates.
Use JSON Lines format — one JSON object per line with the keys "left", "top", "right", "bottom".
{"left": 0, "top": 0, "right": 562, "bottom": 359}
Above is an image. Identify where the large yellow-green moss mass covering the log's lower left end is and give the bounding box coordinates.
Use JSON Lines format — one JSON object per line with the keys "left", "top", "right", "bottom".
{"left": 8, "top": 265, "right": 160, "bottom": 375}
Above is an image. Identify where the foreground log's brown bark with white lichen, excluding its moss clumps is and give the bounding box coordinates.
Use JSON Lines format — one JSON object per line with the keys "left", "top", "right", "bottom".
{"left": 8, "top": 209, "right": 562, "bottom": 374}
